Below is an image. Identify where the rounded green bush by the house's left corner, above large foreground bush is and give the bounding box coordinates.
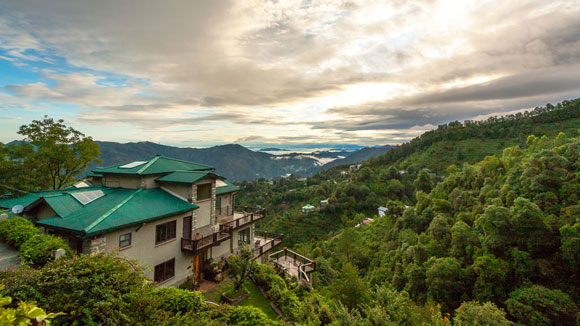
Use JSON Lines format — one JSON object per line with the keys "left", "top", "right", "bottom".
{"left": 18, "top": 234, "right": 72, "bottom": 268}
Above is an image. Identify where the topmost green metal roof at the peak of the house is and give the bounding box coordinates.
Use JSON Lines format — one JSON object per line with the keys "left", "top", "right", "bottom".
{"left": 92, "top": 155, "right": 214, "bottom": 175}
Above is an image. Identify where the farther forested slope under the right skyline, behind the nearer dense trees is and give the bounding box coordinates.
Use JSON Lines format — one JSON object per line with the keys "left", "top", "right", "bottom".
{"left": 240, "top": 100, "right": 580, "bottom": 244}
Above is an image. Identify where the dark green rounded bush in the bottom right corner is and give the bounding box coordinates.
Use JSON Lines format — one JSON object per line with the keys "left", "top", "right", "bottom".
{"left": 506, "top": 285, "right": 578, "bottom": 326}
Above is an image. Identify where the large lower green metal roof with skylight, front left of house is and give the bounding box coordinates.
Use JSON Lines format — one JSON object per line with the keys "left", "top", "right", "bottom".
{"left": 37, "top": 188, "right": 198, "bottom": 236}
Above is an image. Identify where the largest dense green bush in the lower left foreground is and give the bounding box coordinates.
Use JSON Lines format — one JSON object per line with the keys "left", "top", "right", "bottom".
{"left": 0, "top": 254, "right": 157, "bottom": 326}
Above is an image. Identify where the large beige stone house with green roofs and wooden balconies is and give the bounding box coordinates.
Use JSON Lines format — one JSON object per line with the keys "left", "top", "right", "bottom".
{"left": 0, "top": 156, "right": 281, "bottom": 286}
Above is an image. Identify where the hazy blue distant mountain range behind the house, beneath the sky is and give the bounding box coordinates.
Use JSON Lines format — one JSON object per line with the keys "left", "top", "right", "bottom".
{"left": 87, "top": 141, "right": 394, "bottom": 181}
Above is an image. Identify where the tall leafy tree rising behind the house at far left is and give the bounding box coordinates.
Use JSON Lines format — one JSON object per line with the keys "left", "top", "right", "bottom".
{"left": 18, "top": 116, "right": 101, "bottom": 189}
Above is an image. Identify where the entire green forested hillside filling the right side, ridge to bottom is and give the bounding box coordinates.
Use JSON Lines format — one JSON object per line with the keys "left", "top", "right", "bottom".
{"left": 232, "top": 100, "right": 580, "bottom": 325}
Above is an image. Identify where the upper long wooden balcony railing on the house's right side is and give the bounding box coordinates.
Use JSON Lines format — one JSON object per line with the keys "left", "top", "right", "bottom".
{"left": 181, "top": 209, "right": 266, "bottom": 253}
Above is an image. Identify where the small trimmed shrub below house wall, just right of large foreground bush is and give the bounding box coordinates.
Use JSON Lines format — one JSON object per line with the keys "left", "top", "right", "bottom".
{"left": 156, "top": 288, "right": 204, "bottom": 313}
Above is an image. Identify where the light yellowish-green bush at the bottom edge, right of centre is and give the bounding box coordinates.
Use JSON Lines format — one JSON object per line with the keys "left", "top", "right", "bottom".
{"left": 453, "top": 301, "right": 513, "bottom": 326}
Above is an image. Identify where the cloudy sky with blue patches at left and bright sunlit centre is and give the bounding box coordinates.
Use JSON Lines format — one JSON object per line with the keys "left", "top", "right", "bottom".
{"left": 0, "top": 0, "right": 580, "bottom": 147}
